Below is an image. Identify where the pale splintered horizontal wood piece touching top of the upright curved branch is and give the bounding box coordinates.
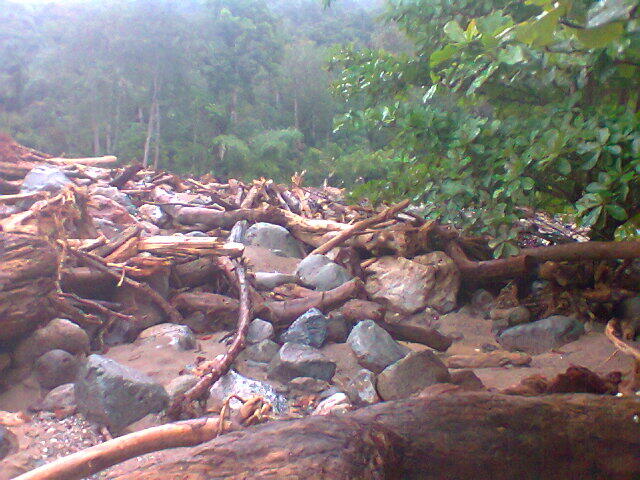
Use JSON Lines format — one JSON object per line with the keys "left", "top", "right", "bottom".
{"left": 138, "top": 235, "right": 244, "bottom": 258}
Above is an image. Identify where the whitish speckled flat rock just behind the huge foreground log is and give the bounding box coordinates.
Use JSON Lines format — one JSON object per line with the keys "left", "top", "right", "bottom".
{"left": 209, "top": 370, "right": 288, "bottom": 415}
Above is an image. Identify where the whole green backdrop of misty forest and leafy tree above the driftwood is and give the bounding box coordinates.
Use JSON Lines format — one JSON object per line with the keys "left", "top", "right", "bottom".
{"left": 0, "top": 0, "right": 640, "bottom": 251}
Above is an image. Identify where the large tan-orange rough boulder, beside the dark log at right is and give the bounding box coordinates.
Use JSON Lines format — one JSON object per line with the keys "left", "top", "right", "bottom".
{"left": 365, "top": 252, "right": 460, "bottom": 315}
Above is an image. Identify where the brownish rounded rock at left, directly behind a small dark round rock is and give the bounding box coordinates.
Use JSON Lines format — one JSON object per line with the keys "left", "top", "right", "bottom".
{"left": 13, "top": 318, "right": 89, "bottom": 366}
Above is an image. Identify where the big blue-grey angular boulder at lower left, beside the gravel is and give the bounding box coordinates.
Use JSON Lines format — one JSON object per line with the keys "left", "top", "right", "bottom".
{"left": 75, "top": 355, "right": 169, "bottom": 432}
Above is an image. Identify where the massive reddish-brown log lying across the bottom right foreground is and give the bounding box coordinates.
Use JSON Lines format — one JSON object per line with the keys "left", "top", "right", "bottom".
{"left": 102, "top": 393, "right": 640, "bottom": 480}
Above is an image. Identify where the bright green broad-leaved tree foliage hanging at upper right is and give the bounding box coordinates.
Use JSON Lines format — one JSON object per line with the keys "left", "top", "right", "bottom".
{"left": 334, "top": 0, "right": 640, "bottom": 248}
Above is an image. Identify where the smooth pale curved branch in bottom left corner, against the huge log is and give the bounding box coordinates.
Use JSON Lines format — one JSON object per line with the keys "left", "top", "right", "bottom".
{"left": 15, "top": 418, "right": 220, "bottom": 480}
